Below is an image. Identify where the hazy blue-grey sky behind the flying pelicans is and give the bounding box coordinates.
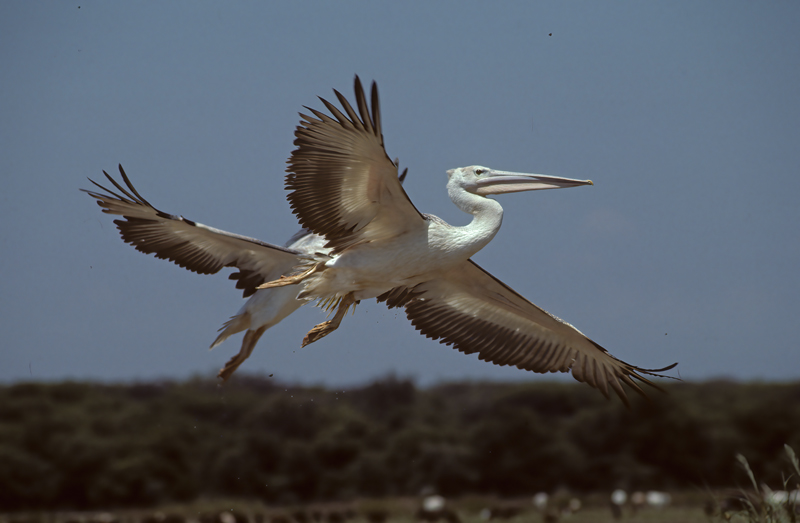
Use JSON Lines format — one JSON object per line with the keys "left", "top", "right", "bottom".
{"left": 0, "top": 0, "right": 800, "bottom": 385}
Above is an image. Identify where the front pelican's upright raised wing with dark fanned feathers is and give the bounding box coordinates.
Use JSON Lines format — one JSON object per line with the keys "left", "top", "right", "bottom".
{"left": 286, "top": 76, "right": 425, "bottom": 252}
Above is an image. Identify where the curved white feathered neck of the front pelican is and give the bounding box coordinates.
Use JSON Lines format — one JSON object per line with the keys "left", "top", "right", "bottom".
{"left": 447, "top": 184, "right": 503, "bottom": 257}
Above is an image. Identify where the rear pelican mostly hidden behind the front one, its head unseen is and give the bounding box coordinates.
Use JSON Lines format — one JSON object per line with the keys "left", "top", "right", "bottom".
{"left": 81, "top": 160, "right": 408, "bottom": 381}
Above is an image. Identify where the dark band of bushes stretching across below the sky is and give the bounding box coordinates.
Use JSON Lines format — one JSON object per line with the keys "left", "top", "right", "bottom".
{"left": 0, "top": 376, "right": 800, "bottom": 510}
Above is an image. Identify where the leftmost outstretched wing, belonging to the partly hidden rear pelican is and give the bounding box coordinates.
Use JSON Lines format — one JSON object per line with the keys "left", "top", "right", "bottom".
{"left": 81, "top": 165, "right": 302, "bottom": 297}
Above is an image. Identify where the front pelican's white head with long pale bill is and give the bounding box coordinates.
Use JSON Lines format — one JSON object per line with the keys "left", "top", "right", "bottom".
{"left": 447, "top": 165, "right": 594, "bottom": 196}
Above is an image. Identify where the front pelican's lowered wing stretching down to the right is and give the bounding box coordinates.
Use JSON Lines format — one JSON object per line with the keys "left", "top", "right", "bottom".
{"left": 378, "top": 260, "right": 677, "bottom": 405}
